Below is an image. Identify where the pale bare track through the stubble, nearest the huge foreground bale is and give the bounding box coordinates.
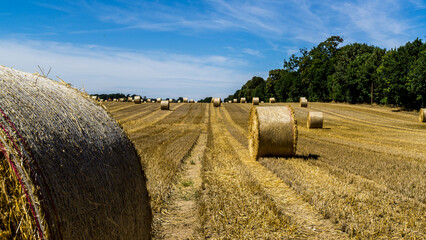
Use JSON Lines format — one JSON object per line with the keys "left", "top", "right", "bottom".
{"left": 161, "top": 107, "right": 208, "bottom": 240}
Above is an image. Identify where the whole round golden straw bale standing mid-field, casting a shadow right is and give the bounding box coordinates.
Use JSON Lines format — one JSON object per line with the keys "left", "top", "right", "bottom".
{"left": 248, "top": 106, "right": 297, "bottom": 160}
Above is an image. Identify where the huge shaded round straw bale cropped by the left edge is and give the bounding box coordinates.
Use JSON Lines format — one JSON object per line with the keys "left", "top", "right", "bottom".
{"left": 0, "top": 67, "right": 152, "bottom": 239}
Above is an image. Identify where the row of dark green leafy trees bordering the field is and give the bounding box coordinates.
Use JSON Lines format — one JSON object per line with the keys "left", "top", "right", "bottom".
{"left": 224, "top": 36, "right": 426, "bottom": 109}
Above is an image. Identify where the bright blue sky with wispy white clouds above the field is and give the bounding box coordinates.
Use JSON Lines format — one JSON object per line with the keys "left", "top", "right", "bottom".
{"left": 0, "top": 0, "right": 426, "bottom": 99}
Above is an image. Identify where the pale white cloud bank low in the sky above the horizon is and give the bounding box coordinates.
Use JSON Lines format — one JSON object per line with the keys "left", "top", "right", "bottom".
{"left": 0, "top": 40, "right": 251, "bottom": 99}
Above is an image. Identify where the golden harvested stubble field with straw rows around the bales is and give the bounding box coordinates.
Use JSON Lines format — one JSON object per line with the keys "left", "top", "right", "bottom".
{"left": 101, "top": 102, "right": 426, "bottom": 239}
